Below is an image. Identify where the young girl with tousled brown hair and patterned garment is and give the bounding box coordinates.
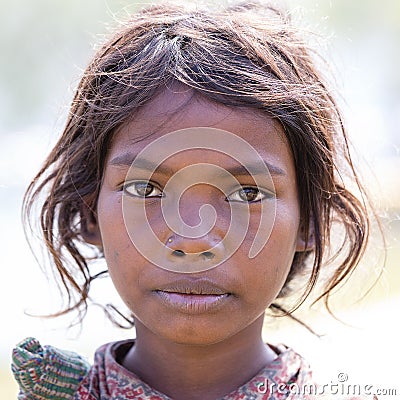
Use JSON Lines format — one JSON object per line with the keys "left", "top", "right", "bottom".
{"left": 12, "top": 2, "right": 378, "bottom": 400}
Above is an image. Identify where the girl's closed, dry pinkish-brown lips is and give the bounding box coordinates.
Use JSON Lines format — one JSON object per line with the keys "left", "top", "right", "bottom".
{"left": 154, "top": 278, "right": 232, "bottom": 314}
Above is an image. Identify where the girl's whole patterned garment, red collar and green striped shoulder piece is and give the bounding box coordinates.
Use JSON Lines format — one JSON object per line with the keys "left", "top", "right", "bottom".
{"left": 12, "top": 338, "right": 376, "bottom": 400}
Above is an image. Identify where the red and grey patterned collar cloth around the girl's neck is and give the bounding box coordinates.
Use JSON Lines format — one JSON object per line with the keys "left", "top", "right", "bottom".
{"left": 74, "top": 341, "right": 321, "bottom": 400}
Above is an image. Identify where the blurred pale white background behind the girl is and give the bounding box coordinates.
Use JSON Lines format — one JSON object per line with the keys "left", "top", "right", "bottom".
{"left": 0, "top": 0, "right": 400, "bottom": 399}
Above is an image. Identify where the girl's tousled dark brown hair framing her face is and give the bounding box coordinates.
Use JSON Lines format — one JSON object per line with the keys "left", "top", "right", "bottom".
{"left": 24, "top": 2, "right": 369, "bottom": 324}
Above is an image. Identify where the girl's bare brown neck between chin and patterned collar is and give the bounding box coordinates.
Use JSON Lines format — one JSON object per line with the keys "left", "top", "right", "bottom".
{"left": 123, "top": 317, "right": 276, "bottom": 400}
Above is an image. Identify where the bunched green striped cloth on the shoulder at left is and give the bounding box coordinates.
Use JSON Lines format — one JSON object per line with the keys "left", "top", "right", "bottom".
{"left": 11, "top": 338, "right": 90, "bottom": 400}
